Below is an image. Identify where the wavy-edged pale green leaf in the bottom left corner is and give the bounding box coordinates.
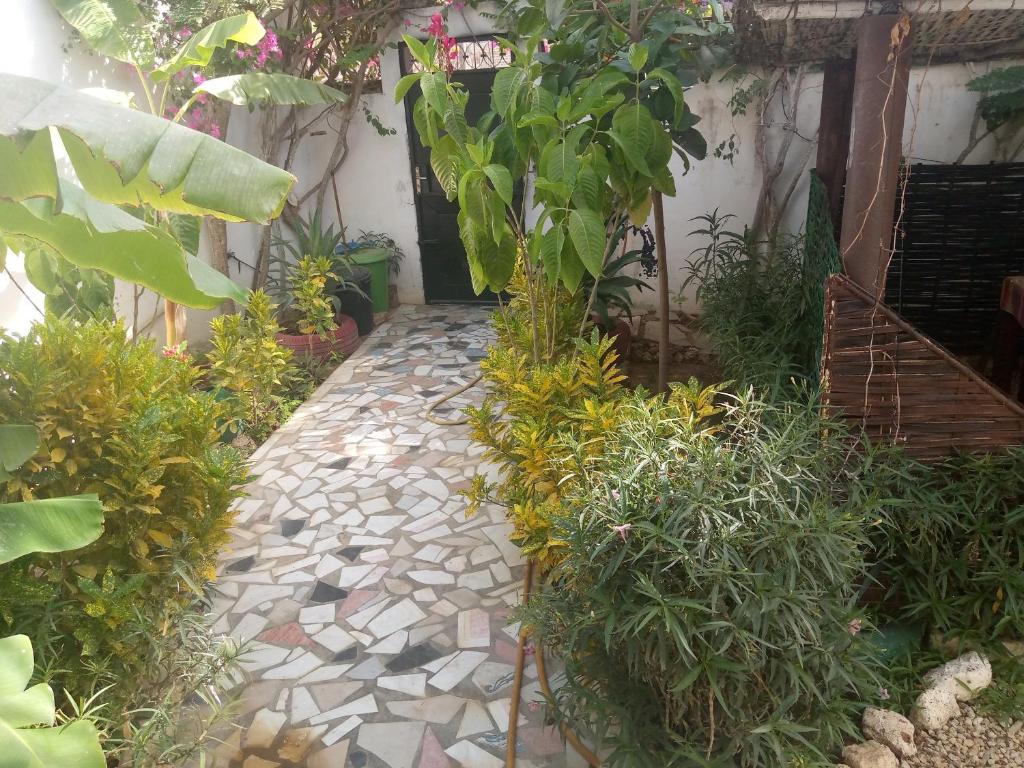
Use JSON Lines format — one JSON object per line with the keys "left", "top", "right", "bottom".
{"left": 0, "top": 635, "right": 106, "bottom": 768}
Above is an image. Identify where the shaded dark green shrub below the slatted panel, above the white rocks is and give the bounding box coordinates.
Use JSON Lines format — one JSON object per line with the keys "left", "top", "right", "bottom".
{"left": 871, "top": 449, "right": 1024, "bottom": 639}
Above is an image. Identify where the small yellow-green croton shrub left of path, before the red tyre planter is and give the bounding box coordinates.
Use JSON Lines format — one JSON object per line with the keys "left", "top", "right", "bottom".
{"left": 208, "top": 291, "right": 295, "bottom": 442}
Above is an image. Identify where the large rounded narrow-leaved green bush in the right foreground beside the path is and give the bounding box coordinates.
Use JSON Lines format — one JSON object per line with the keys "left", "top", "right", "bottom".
{"left": 526, "top": 389, "right": 879, "bottom": 768}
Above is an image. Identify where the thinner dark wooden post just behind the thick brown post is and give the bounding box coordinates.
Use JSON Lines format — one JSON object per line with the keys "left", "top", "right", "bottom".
{"left": 815, "top": 58, "right": 856, "bottom": 234}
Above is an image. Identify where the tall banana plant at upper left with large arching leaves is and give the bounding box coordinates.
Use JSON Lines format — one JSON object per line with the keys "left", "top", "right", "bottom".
{"left": 23, "top": 0, "right": 345, "bottom": 344}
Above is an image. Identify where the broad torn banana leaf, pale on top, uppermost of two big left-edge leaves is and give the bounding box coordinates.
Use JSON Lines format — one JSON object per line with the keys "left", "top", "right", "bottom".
{"left": 0, "top": 75, "right": 295, "bottom": 223}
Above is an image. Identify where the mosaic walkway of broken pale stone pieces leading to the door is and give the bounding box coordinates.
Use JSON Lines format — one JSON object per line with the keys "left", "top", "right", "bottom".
{"left": 213, "top": 306, "right": 584, "bottom": 768}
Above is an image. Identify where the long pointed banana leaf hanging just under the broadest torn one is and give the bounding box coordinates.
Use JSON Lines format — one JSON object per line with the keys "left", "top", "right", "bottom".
{"left": 0, "top": 179, "right": 246, "bottom": 309}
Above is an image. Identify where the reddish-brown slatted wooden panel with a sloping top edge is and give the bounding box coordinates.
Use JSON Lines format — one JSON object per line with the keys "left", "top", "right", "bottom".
{"left": 821, "top": 274, "right": 1024, "bottom": 459}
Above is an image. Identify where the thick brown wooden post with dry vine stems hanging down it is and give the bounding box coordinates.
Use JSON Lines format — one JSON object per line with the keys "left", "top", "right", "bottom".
{"left": 840, "top": 14, "right": 910, "bottom": 298}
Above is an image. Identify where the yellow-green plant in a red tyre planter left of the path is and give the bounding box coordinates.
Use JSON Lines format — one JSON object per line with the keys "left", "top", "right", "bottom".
{"left": 278, "top": 255, "right": 359, "bottom": 359}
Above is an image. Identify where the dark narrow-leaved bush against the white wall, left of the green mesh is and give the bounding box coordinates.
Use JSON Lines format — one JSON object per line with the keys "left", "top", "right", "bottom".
{"left": 680, "top": 211, "right": 830, "bottom": 398}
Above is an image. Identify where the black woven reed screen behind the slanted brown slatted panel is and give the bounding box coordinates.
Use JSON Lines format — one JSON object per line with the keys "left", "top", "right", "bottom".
{"left": 886, "top": 163, "right": 1024, "bottom": 355}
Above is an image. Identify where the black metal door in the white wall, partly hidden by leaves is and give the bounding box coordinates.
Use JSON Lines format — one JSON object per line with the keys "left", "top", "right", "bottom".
{"left": 401, "top": 51, "right": 498, "bottom": 304}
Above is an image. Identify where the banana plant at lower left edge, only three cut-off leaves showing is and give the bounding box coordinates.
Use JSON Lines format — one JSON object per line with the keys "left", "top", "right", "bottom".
{"left": 0, "top": 424, "right": 106, "bottom": 768}
